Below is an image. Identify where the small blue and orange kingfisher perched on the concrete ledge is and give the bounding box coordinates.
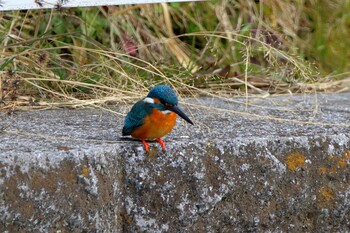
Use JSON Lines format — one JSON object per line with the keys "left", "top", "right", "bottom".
{"left": 122, "top": 85, "right": 193, "bottom": 152}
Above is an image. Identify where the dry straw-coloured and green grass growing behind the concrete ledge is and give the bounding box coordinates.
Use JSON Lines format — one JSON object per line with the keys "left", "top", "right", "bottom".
{"left": 0, "top": 0, "right": 350, "bottom": 111}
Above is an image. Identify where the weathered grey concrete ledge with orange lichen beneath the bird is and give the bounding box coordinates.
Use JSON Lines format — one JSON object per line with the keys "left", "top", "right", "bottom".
{"left": 0, "top": 93, "right": 350, "bottom": 232}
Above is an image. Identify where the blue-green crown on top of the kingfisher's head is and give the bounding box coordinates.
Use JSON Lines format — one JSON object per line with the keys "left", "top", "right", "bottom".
{"left": 147, "top": 85, "right": 178, "bottom": 106}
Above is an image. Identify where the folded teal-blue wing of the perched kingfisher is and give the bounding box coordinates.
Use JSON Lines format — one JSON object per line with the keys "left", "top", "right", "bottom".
{"left": 122, "top": 100, "right": 152, "bottom": 136}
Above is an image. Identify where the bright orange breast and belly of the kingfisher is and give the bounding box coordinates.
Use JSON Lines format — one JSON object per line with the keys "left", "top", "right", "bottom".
{"left": 131, "top": 108, "right": 176, "bottom": 139}
